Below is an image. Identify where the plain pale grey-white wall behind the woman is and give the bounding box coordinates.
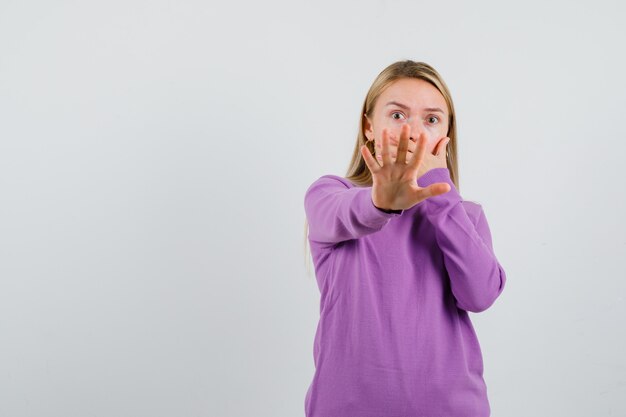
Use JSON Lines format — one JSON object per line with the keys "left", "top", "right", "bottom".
{"left": 0, "top": 0, "right": 626, "bottom": 417}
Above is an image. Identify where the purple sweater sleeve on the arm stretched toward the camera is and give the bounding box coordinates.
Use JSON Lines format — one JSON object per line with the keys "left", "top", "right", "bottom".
{"left": 304, "top": 176, "right": 404, "bottom": 245}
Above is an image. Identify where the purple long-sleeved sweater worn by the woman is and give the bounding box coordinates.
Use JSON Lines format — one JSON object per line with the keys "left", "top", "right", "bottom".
{"left": 304, "top": 168, "right": 506, "bottom": 417}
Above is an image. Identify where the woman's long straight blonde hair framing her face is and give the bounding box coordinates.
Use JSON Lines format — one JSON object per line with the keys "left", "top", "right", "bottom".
{"left": 304, "top": 60, "right": 460, "bottom": 272}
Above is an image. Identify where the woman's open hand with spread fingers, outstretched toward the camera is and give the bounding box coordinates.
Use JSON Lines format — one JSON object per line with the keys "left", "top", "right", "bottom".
{"left": 361, "top": 124, "right": 450, "bottom": 210}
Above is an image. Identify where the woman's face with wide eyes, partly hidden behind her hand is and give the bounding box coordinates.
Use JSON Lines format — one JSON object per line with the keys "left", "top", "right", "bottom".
{"left": 364, "top": 78, "right": 449, "bottom": 158}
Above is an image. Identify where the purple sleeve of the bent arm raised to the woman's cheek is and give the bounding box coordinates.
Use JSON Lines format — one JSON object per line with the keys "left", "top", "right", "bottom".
{"left": 418, "top": 168, "right": 506, "bottom": 313}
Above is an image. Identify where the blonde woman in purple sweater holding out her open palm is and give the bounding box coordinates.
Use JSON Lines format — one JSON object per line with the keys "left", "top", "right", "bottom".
{"left": 304, "top": 60, "right": 506, "bottom": 417}
